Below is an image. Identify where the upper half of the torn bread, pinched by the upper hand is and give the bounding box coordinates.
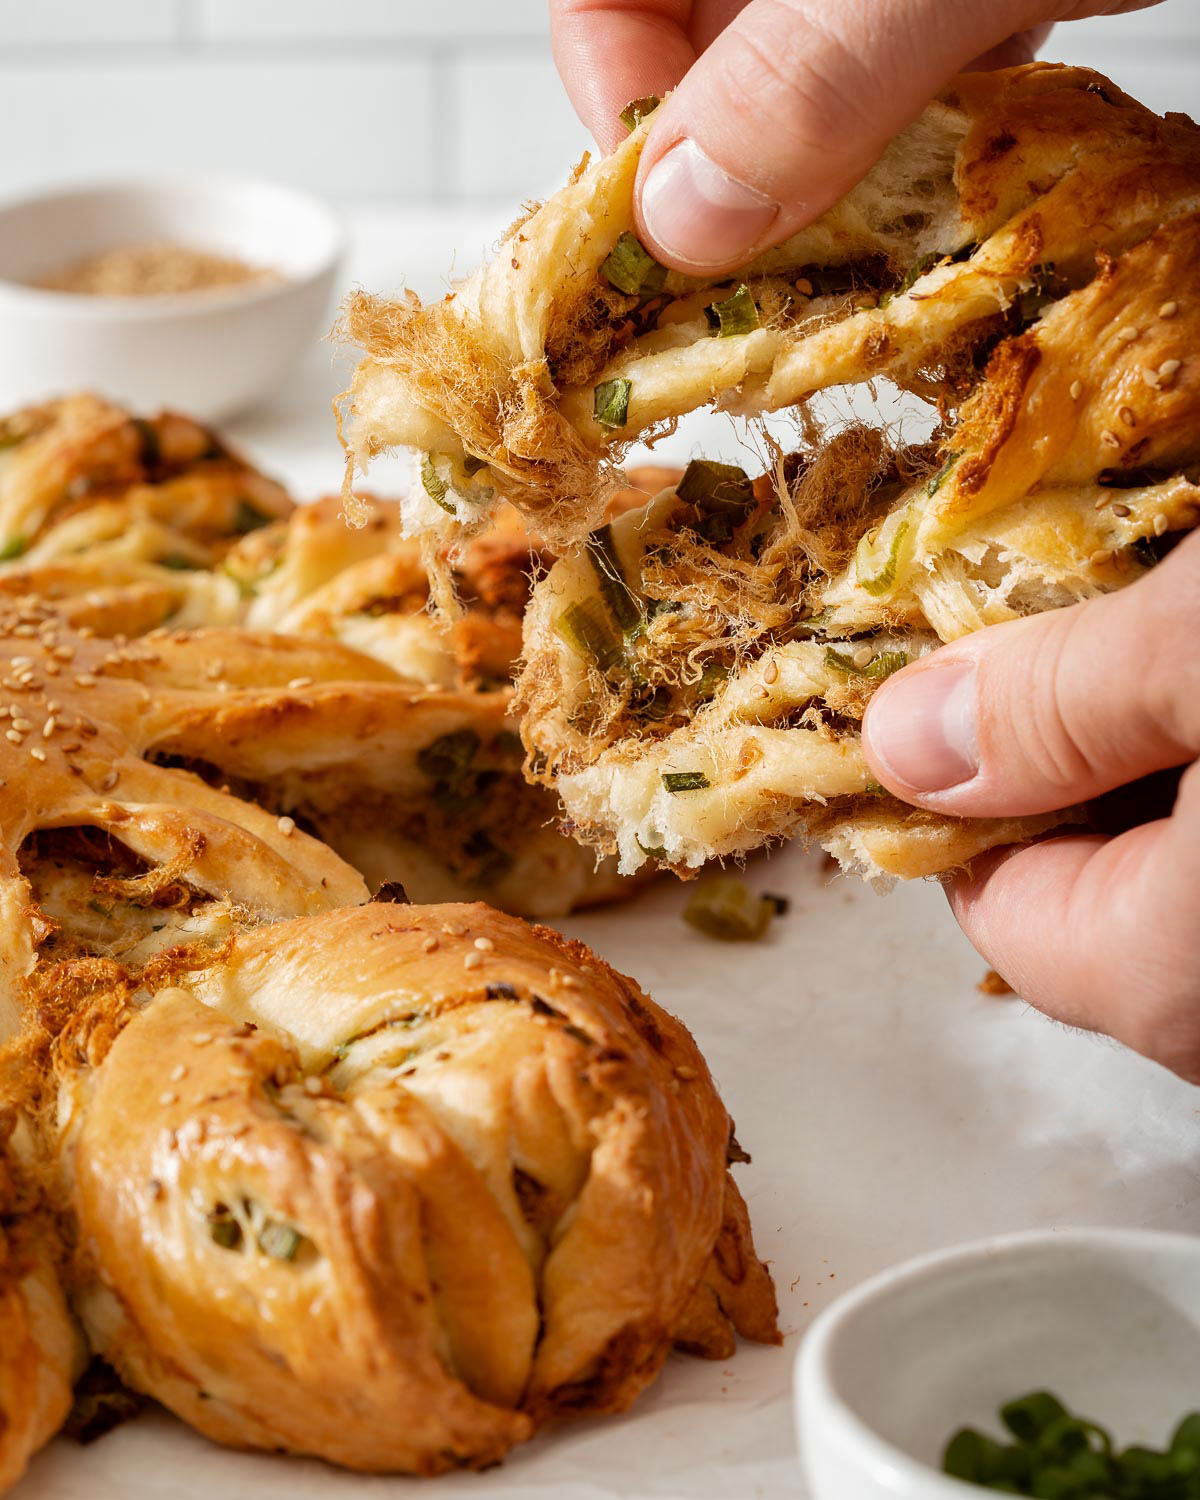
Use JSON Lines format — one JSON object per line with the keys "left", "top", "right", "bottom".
{"left": 341, "top": 63, "right": 1200, "bottom": 549}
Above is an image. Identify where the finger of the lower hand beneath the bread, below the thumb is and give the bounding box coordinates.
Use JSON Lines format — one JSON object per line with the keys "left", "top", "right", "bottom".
{"left": 948, "top": 773, "right": 1200, "bottom": 1082}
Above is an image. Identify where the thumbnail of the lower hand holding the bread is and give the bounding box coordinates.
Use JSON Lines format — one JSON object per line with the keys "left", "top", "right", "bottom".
{"left": 864, "top": 662, "right": 980, "bottom": 792}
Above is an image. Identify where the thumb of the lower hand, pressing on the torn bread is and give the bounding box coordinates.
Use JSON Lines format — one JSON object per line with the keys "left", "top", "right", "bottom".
{"left": 863, "top": 536, "right": 1200, "bottom": 818}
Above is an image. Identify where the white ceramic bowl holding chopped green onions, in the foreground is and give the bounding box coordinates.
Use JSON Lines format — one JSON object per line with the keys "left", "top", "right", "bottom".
{"left": 797, "top": 1230, "right": 1200, "bottom": 1500}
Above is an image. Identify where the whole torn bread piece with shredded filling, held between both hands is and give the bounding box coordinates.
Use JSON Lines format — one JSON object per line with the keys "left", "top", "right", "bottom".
{"left": 337, "top": 65, "right": 1200, "bottom": 878}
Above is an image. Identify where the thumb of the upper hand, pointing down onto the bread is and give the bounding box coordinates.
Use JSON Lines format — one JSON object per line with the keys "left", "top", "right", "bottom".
{"left": 638, "top": 0, "right": 1037, "bottom": 273}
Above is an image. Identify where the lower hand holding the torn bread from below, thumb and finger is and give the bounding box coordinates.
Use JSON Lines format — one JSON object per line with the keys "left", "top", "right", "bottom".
{"left": 863, "top": 536, "right": 1200, "bottom": 1083}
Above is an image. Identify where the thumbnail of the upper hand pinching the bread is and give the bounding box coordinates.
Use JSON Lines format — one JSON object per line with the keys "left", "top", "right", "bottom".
{"left": 642, "top": 138, "right": 779, "bottom": 266}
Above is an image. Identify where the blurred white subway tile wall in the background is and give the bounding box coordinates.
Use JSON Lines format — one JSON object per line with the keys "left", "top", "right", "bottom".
{"left": 0, "top": 0, "right": 1200, "bottom": 207}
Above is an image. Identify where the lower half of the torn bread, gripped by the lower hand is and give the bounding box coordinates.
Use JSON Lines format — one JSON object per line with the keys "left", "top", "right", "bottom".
{"left": 519, "top": 213, "right": 1200, "bottom": 878}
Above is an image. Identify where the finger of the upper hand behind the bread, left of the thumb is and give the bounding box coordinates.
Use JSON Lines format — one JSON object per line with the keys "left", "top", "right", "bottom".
{"left": 551, "top": 0, "right": 696, "bottom": 152}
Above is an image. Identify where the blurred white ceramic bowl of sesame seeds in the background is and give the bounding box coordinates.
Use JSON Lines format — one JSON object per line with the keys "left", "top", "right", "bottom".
{"left": 0, "top": 177, "right": 344, "bottom": 422}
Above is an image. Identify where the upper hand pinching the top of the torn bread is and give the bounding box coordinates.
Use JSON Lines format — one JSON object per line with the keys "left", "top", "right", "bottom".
{"left": 551, "top": 0, "right": 1155, "bottom": 275}
